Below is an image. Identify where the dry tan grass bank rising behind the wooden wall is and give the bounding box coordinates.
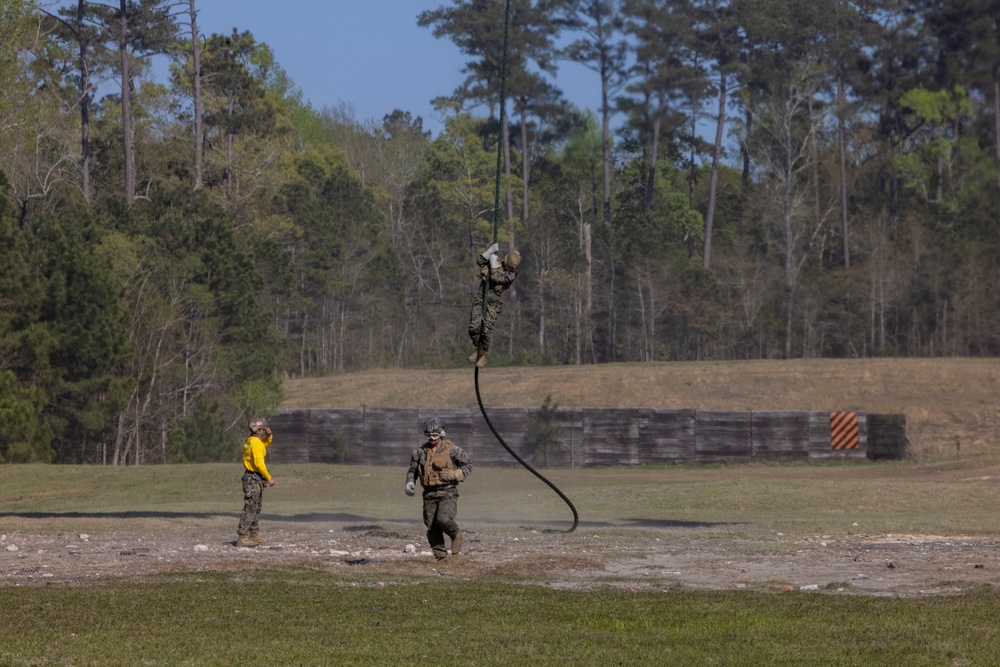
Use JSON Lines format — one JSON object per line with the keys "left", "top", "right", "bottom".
{"left": 282, "top": 358, "right": 1000, "bottom": 460}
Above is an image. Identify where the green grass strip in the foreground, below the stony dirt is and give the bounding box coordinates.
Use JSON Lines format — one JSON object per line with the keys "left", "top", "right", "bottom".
{"left": 0, "top": 570, "right": 1000, "bottom": 667}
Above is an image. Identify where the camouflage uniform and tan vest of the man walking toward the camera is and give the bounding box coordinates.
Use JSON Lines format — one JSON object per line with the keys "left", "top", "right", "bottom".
{"left": 406, "top": 440, "right": 472, "bottom": 560}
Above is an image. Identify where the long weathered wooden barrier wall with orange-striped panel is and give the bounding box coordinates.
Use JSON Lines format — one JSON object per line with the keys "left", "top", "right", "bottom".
{"left": 268, "top": 408, "right": 906, "bottom": 468}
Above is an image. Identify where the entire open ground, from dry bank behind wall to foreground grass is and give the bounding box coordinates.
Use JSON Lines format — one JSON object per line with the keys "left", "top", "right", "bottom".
{"left": 0, "top": 362, "right": 1000, "bottom": 667}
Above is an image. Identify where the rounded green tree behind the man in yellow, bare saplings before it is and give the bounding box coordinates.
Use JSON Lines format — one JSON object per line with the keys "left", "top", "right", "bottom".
{"left": 100, "top": 184, "right": 280, "bottom": 465}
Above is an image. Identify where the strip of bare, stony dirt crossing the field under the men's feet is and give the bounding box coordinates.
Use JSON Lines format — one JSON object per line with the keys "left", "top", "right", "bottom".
{"left": 0, "top": 520, "right": 1000, "bottom": 597}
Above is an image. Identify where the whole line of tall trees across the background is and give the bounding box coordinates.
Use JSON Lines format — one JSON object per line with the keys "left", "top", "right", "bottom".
{"left": 0, "top": 0, "right": 1000, "bottom": 465}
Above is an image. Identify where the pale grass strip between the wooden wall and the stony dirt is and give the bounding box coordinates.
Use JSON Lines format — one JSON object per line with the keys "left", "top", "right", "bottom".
{"left": 0, "top": 457, "right": 1000, "bottom": 537}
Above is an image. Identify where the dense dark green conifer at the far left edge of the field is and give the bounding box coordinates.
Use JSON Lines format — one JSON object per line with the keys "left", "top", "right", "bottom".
{"left": 0, "top": 180, "right": 129, "bottom": 462}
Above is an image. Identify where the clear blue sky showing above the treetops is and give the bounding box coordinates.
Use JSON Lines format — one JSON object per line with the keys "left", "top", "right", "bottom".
{"left": 196, "top": 0, "right": 600, "bottom": 134}
